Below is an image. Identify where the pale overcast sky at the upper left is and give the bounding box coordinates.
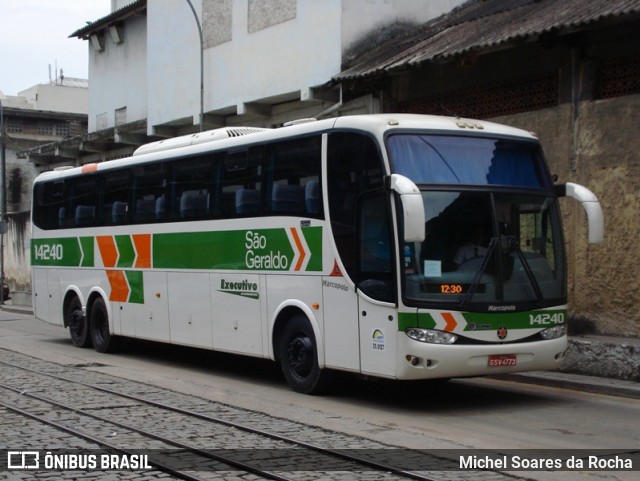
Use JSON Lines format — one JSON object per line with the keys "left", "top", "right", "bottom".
{"left": 0, "top": 0, "right": 111, "bottom": 95}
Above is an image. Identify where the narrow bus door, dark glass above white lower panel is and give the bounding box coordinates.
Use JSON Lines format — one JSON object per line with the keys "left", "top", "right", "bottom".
{"left": 357, "top": 191, "right": 398, "bottom": 377}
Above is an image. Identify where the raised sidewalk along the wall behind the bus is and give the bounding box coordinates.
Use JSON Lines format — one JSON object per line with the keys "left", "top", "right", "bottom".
{"left": 0, "top": 301, "right": 640, "bottom": 399}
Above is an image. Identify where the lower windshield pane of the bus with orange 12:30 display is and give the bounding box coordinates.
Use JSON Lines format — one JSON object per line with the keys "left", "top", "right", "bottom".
{"left": 403, "top": 190, "right": 566, "bottom": 310}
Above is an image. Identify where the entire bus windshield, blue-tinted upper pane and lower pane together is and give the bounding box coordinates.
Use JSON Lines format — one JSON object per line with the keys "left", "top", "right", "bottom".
{"left": 387, "top": 134, "right": 566, "bottom": 311}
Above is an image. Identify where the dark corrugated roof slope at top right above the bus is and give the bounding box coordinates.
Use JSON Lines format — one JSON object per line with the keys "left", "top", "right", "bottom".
{"left": 334, "top": 0, "right": 640, "bottom": 81}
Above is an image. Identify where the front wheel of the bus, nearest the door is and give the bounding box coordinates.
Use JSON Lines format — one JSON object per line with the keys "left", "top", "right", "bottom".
{"left": 279, "top": 315, "right": 329, "bottom": 394}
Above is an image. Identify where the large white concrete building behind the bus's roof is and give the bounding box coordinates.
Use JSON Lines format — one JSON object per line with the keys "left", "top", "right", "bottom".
{"left": 23, "top": 0, "right": 463, "bottom": 166}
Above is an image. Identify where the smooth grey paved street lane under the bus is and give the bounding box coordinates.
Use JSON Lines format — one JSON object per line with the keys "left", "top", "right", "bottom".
{"left": 0, "top": 311, "right": 640, "bottom": 480}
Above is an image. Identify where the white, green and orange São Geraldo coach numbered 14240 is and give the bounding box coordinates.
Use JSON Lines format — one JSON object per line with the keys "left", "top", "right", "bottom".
{"left": 31, "top": 114, "right": 603, "bottom": 393}
